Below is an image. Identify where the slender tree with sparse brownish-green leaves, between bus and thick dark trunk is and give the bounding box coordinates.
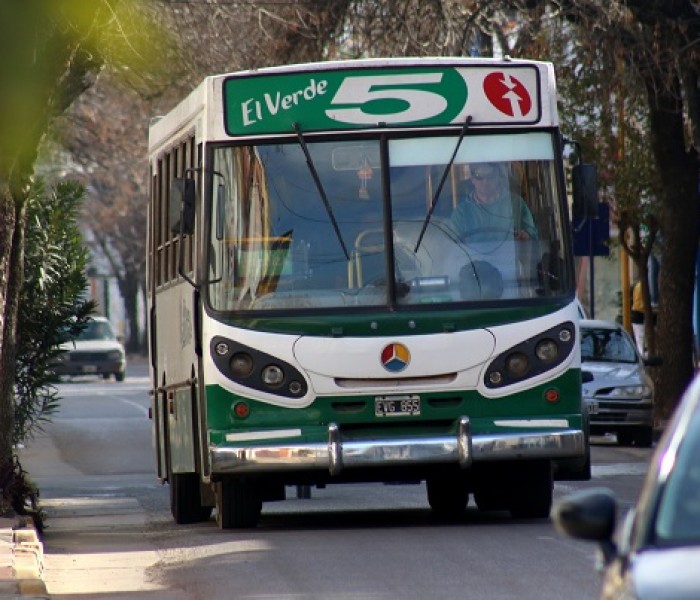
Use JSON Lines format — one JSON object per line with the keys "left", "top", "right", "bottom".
{"left": 543, "top": 14, "right": 661, "bottom": 354}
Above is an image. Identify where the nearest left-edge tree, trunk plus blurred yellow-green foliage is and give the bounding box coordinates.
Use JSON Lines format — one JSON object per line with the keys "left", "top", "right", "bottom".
{"left": 0, "top": 0, "right": 165, "bottom": 516}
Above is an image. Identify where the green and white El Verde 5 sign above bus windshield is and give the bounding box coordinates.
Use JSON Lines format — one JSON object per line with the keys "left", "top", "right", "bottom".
{"left": 223, "top": 65, "right": 542, "bottom": 136}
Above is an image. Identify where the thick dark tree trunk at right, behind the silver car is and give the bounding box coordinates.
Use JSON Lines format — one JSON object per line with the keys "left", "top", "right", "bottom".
{"left": 645, "top": 80, "right": 699, "bottom": 420}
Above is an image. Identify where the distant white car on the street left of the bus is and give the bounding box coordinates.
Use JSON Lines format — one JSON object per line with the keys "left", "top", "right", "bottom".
{"left": 53, "top": 317, "right": 126, "bottom": 381}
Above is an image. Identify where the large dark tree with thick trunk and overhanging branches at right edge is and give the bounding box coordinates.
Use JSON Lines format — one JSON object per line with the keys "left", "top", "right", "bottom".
{"left": 552, "top": 0, "right": 700, "bottom": 418}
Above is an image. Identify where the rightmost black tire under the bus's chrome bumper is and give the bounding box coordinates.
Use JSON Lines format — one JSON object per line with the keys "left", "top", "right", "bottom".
{"left": 509, "top": 460, "right": 554, "bottom": 519}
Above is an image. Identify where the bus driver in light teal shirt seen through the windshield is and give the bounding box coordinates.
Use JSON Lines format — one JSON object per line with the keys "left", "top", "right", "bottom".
{"left": 450, "top": 162, "right": 537, "bottom": 242}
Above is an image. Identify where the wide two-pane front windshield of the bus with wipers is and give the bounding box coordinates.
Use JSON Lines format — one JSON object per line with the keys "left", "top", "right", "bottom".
{"left": 208, "top": 132, "right": 573, "bottom": 311}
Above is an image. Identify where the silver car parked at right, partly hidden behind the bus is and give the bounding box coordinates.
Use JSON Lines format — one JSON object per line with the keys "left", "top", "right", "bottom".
{"left": 580, "top": 319, "right": 660, "bottom": 448}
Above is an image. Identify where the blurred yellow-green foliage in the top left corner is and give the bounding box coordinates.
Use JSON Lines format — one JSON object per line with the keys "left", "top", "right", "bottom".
{"left": 0, "top": 0, "right": 167, "bottom": 182}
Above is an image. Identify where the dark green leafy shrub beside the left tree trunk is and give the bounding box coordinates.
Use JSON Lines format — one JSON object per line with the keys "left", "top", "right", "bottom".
{"left": 13, "top": 180, "right": 94, "bottom": 443}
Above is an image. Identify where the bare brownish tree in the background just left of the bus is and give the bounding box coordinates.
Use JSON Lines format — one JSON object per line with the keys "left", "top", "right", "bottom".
{"left": 59, "top": 0, "right": 251, "bottom": 352}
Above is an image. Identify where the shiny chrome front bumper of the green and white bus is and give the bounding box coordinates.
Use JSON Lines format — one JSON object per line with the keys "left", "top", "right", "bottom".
{"left": 209, "top": 417, "right": 585, "bottom": 475}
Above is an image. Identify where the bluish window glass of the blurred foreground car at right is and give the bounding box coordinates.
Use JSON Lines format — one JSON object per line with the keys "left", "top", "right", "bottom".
{"left": 656, "top": 410, "right": 700, "bottom": 545}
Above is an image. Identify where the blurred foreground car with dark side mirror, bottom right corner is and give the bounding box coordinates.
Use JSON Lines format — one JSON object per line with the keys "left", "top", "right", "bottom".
{"left": 552, "top": 377, "right": 700, "bottom": 600}
